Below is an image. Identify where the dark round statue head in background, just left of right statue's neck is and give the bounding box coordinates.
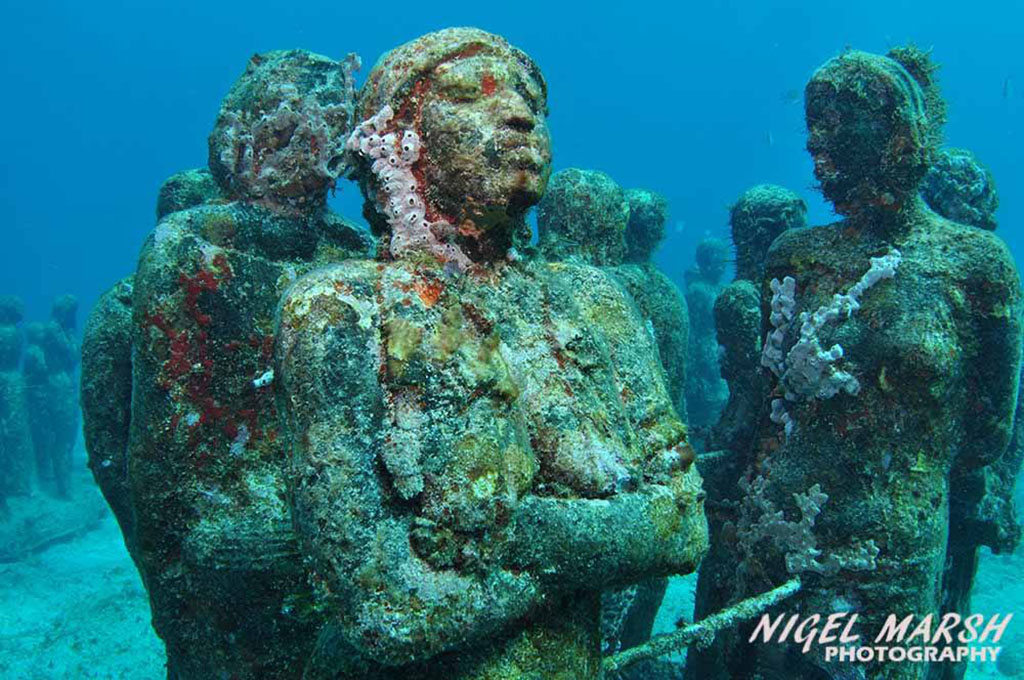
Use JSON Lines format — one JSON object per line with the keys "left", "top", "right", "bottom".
{"left": 729, "top": 184, "right": 807, "bottom": 283}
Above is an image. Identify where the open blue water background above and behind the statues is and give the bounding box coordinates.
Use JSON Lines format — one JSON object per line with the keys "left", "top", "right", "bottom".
{"left": 0, "top": 0, "right": 1024, "bottom": 317}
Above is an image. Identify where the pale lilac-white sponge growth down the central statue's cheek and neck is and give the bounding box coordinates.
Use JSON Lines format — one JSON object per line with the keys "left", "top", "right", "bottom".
{"left": 346, "top": 104, "right": 471, "bottom": 268}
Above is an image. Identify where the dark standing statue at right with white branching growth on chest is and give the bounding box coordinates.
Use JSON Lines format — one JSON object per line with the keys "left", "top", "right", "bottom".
{"left": 687, "top": 51, "right": 1021, "bottom": 678}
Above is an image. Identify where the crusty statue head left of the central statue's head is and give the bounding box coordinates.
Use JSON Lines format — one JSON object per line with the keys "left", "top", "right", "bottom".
{"left": 209, "top": 49, "right": 358, "bottom": 209}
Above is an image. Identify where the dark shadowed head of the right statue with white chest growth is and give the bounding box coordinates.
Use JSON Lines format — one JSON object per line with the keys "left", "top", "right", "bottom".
{"left": 804, "top": 51, "right": 939, "bottom": 217}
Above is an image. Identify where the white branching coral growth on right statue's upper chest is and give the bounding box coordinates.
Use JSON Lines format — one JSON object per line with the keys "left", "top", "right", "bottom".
{"left": 761, "top": 249, "right": 902, "bottom": 435}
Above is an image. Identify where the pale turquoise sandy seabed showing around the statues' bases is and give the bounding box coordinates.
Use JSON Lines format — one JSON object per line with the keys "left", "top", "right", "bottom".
{"left": 0, "top": 473, "right": 1024, "bottom": 680}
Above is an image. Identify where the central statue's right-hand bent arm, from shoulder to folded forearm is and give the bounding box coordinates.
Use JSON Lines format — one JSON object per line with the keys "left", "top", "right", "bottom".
{"left": 513, "top": 267, "right": 708, "bottom": 589}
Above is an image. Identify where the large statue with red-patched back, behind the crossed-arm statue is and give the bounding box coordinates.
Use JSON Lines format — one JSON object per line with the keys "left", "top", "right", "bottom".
{"left": 82, "top": 50, "right": 372, "bottom": 680}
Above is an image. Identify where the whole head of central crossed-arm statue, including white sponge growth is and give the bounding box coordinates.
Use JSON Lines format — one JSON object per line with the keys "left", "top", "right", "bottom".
{"left": 349, "top": 28, "right": 551, "bottom": 264}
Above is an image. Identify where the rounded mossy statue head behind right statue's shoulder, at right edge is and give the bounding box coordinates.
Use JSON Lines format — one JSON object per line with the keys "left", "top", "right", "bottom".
{"left": 921, "top": 148, "right": 999, "bottom": 229}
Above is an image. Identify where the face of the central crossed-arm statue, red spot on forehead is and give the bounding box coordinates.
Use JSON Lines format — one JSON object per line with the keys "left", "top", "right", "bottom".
{"left": 420, "top": 54, "right": 551, "bottom": 229}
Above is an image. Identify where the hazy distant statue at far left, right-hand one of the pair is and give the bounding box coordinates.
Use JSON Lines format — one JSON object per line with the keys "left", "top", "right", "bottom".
{"left": 22, "top": 295, "right": 79, "bottom": 498}
